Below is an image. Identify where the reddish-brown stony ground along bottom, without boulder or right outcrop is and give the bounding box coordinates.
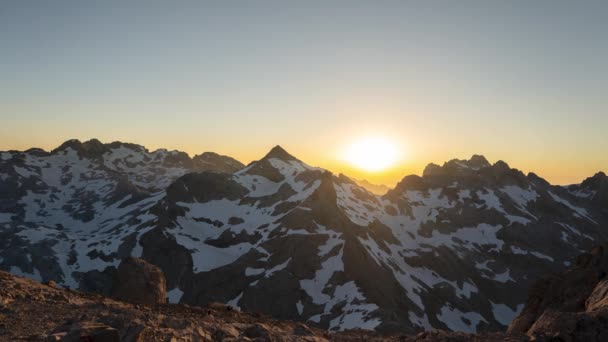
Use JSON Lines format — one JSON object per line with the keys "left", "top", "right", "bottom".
{"left": 0, "top": 271, "right": 525, "bottom": 342}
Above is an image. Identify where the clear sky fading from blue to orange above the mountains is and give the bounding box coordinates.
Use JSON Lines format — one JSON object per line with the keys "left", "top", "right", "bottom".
{"left": 0, "top": 0, "right": 608, "bottom": 185}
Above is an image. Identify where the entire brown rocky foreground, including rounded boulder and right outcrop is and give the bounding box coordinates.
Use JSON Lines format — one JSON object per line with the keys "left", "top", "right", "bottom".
{"left": 5, "top": 245, "right": 608, "bottom": 342}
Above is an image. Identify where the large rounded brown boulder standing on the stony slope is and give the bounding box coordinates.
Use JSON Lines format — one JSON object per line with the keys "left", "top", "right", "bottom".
{"left": 110, "top": 257, "right": 167, "bottom": 305}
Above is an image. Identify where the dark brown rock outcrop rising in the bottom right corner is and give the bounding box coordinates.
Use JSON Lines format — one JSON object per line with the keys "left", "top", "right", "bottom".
{"left": 508, "top": 245, "right": 608, "bottom": 342}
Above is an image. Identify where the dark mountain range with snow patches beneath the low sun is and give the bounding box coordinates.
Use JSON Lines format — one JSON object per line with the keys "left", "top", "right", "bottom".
{"left": 0, "top": 145, "right": 608, "bottom": 332}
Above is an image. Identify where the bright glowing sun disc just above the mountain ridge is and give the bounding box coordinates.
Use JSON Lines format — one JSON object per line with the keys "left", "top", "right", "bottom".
{"left": 344, "top": 137, "right": 399, "bottom": 172}
